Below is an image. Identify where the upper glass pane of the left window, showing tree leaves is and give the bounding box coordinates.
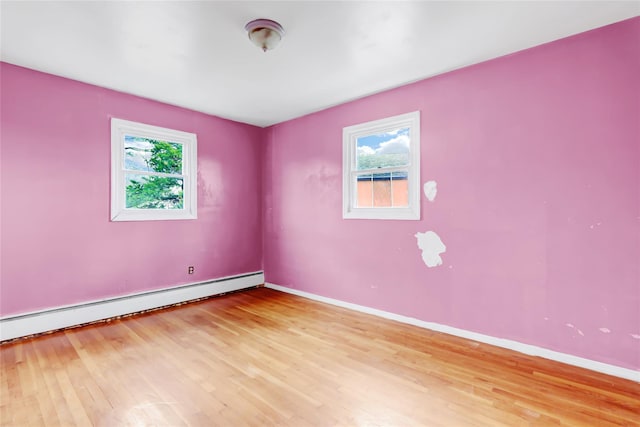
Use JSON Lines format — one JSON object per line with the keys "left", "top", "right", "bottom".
{"left": 124, "top": 135, "right": 182, "bottom": 174}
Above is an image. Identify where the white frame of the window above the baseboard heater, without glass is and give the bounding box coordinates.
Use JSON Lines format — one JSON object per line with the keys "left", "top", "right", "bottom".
{"left": 111, "top": 117, "right": 198, "bottom": 221}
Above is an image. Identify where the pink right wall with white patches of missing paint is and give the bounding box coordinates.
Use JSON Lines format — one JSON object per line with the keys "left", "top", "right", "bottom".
{"left": 264, "top": 18, "right": 640, "bottom": 369}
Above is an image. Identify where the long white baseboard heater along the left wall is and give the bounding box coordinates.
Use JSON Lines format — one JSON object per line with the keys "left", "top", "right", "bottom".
{"left": 0, "top": 271, "right": 264, "bottom": 341}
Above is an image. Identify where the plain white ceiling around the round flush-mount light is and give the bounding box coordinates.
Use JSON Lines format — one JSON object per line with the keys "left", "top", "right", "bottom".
{"left": 0, "top": 0, "right": 640, "bottom": 126}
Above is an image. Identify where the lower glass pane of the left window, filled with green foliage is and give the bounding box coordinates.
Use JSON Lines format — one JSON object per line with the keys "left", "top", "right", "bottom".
{"left": 125, "top": 173, "right": 184, "bottom": 209}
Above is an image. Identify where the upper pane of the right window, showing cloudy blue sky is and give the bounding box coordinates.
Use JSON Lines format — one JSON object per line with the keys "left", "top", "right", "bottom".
{"left": 356, "top": 127, "right": 409, "bottom": 170}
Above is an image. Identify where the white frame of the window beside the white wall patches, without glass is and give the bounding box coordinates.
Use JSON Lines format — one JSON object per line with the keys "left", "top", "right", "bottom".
{"left": 342, "top": 111, "right": 420, "bottom": 220}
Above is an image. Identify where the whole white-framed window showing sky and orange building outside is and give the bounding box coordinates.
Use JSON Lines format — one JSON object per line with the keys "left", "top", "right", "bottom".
{"left": 342, "top": 111, "right": 420, "bottom": 220}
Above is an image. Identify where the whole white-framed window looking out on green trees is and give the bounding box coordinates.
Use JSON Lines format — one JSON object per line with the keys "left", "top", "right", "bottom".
{"left": 111, "top": 118, "right": 197, "bottom": 221}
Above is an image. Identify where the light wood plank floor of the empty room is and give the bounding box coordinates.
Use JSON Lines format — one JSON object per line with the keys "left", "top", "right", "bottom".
{"left": 0, "top": 288, "right": 640, "bottom": 427}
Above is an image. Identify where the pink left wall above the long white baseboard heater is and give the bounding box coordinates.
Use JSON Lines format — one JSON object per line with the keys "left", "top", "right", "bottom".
{"left": 0, "top": 63, "right": 264, "bottom": 316}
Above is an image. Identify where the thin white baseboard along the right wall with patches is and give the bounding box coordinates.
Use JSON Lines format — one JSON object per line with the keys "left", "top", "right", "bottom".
{"left": 265, "top": 283, "right": 640, "bottom": 382}
